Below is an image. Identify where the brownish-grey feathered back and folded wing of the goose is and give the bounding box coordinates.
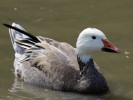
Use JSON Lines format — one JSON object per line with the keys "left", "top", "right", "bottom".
{"left": 17, "top": 36, "right": 79, "bottom": 90}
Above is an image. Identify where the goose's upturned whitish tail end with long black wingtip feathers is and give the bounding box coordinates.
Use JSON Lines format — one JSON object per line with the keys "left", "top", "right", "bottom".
{"left": 3, "top": 23, "right": 40, "bottom": 54}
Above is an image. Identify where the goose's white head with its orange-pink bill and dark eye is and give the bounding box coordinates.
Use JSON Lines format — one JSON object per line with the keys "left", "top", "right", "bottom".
{"left": 76, "top": 28, "right": 119, "bottom": 62}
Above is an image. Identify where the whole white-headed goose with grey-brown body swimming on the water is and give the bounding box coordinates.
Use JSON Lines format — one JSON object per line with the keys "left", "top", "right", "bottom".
{"left": 3, "top": 23, "right": 120, "bottom": 94}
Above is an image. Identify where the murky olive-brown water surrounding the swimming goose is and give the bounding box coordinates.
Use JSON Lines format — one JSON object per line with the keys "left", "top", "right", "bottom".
{"left": 0, "top": 0, "right": 133, "bottom": 100}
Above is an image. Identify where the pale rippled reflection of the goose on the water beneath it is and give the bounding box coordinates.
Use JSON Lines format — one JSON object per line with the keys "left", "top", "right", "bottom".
{"left": 7, "top": 78, "right": 104, "bottom": 100}
